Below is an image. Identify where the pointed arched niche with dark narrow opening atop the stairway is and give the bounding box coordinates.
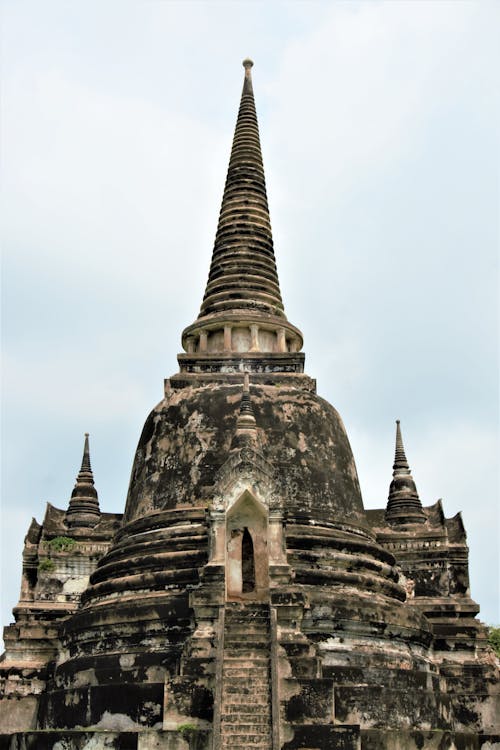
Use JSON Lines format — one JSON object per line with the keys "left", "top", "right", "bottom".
{"left": 226, "top": 491, "right": 269, "bottom": 601}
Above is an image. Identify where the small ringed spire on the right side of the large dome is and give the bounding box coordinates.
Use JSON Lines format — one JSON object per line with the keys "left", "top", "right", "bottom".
{"left": 385, "top": 419, "right": 426, "bottom": 524}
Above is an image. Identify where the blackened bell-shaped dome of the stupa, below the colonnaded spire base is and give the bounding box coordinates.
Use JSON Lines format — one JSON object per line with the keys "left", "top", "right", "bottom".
{"left": 124, "top": 384, "right": 366, "bottom": 527}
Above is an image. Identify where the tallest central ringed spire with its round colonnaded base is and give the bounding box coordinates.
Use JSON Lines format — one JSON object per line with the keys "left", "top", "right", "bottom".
{"left": 179, "top": 58, "right": 303, "bottom": 372}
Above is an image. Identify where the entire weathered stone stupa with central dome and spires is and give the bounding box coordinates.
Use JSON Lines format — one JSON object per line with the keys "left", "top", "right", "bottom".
{"left": 0, "top": 60, "right": 500, "bottom": 750}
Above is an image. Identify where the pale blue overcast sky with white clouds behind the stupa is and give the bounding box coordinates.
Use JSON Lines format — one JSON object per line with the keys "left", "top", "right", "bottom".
{"left": 1, "top": 0, "right": 500, "bottom": 648}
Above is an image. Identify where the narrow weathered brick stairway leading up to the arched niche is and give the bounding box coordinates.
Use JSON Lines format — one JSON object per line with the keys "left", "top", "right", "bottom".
{"left": 220, "top": 602, "right": 272, "bottom": 750}
